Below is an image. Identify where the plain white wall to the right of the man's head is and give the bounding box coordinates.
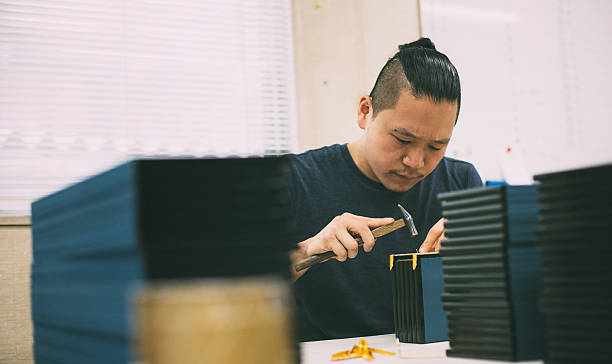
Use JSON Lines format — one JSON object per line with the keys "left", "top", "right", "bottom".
{"left": 420, "top": 0, "right": 612, "bottom": 180}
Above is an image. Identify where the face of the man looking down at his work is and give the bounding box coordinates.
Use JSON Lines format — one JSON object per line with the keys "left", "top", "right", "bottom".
{"left": 358, "top": 91, "right": 457, "bottom": 192}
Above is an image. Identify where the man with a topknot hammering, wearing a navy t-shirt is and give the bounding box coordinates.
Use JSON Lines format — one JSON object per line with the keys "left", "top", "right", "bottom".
{"left": 290, "top": 38, "right": 482, "bottom": 340}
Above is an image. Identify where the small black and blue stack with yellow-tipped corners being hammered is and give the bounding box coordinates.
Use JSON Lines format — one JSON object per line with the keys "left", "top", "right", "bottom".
{"left": 389, "top": 253, "right": 448, "bottom": 344}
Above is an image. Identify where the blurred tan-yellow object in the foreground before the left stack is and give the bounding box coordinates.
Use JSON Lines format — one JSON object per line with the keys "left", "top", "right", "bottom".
{"left": 134, "top": 278, "right": 295, "bottom": 364}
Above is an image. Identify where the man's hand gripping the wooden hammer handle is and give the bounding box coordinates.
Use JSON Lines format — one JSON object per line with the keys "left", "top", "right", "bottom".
{"left": 291, "top": 212, "right": 394, "bottom": 280}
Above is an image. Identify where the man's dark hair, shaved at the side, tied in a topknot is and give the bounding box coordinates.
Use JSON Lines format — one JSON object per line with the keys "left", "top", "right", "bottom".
{"left": 370, "top": 38, "right": 461, "bottom": 123}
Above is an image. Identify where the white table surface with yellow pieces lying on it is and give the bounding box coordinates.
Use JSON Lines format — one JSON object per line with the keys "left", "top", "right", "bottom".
{"left": 300, "top": 334, "right": 542, "bottom": 364}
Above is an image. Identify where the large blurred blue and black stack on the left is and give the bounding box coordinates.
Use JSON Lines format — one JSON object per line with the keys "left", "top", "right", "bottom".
{"left": 32, "top": 157, "right": 294, "bottom": 364}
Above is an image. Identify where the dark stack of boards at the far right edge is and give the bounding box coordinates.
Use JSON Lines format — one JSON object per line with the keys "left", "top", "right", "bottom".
{"left": 535, "top": 165, "right": 612, "bottom": 363}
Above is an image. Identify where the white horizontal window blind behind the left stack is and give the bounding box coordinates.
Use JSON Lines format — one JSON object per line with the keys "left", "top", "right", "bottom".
{"left": 0, "top": 0, "right": 297, "bottom": 215}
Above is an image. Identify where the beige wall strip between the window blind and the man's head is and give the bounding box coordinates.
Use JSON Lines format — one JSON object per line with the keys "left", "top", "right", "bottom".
{"left": 293, "top": 0, "right": 420, "bottom": 151}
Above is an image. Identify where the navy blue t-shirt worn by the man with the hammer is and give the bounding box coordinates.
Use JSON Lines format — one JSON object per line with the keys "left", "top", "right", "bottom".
{"left": 289, "top": 144, "right": 482, "bottom": 341}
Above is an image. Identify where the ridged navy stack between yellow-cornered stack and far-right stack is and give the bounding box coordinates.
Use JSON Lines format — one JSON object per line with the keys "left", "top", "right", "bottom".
{"left": 438, "top": 185, "right": 546, "bottom": 361}
